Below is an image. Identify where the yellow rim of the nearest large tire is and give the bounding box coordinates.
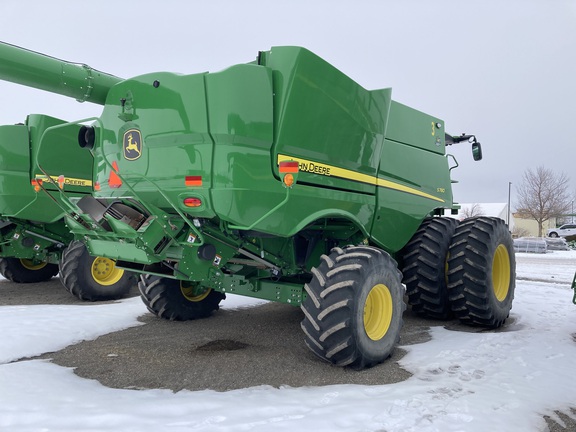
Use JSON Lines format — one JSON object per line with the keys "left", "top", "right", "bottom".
{"left": 364, "top": 284, "right": 394, "bottom": 341}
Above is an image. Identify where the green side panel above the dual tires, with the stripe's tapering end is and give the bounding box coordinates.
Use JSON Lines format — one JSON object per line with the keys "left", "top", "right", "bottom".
{"left": 371, "top": 102, "right": 452, "bottom": 253}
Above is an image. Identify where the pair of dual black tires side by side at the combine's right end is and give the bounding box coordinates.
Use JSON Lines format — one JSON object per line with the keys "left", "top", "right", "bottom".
{"left": 403, "top": 216, "right": 516, "bottom": 328}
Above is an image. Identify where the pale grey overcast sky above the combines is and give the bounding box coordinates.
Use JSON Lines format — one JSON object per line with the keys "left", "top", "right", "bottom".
{"left": 0, "top": 0, "right": 576, "bottom": 208}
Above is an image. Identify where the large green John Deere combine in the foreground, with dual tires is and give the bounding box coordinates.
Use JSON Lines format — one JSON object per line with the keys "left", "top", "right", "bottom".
{"left": 0, "top": 41, "right": 515, "bottom": 369}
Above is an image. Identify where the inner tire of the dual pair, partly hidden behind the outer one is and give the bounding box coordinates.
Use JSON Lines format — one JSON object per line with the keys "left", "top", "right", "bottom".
{"left": 402, "top": 217, "right": 458, "bottom": 320}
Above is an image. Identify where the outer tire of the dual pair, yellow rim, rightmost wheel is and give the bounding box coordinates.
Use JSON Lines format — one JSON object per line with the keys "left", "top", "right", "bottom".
{"left": 448, "top": 216, "right": 516, "bottom": 328}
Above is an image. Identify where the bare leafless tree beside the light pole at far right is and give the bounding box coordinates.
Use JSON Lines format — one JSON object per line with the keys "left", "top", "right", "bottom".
{"left": 516, "top": 166, "right": 572, "bottom": 237}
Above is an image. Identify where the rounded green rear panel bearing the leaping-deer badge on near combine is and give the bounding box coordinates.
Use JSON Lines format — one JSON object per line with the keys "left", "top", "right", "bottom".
{"left": 94, "top": 72, "right": 214, "bottom": 217}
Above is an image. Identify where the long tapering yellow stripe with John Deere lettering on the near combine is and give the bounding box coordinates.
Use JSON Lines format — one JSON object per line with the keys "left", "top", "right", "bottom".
{"left": 278, "top": 154, "right": 444, "bottom": 202}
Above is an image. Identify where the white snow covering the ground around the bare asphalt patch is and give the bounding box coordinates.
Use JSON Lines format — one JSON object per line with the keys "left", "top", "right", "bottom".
{"left": 0, "top": 251, "right": 576, "bottom": 432}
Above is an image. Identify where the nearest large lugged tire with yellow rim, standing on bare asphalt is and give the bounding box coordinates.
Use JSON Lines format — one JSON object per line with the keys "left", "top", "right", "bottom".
{"left": 301, "top": 246, "right": 405, "bottom": 369}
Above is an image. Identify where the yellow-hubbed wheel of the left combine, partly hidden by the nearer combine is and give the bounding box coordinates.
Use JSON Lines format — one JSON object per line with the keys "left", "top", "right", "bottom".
{"left": 60, "top": 241, "right": 136, "bottom": 301}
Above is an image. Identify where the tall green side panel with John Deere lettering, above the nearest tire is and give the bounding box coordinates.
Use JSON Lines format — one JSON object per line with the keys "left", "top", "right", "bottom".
{"left": 222, "top": 47, "right": 390, "bottom": 236}
